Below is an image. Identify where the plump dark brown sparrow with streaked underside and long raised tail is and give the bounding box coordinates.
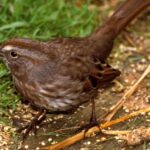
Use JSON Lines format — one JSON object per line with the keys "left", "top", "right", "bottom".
{"left": 0, "top": 0, "right": 150, "bottom": 137}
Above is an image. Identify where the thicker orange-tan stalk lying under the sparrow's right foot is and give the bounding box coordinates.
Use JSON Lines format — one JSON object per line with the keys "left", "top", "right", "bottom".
{"left": 43, "top": 107, "right": 150, "bottom": 150}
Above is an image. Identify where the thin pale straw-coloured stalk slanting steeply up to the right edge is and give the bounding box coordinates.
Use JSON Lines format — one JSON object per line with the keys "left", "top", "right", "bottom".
{"left": 104, "top": 65, "right": 150, "bottom": 121}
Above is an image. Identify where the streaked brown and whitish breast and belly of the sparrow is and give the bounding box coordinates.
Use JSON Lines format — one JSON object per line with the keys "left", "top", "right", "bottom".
{"left": 15, "top": 77, "right": 91, "bottom": 112}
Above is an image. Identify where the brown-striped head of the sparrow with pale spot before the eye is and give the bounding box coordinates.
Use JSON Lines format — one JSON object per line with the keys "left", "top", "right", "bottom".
{"left": 0, "top": 39, "right": 54, "bottom": 77}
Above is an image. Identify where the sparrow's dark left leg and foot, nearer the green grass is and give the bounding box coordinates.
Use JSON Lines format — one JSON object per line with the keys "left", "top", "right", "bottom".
{"left": 17, "top": 109, "right": 47, "bottom": 140}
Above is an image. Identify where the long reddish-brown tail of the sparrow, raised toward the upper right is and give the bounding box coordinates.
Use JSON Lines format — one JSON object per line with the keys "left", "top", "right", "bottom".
{"left": 89, "top": 0, "right": 150, "bottom": 60}
